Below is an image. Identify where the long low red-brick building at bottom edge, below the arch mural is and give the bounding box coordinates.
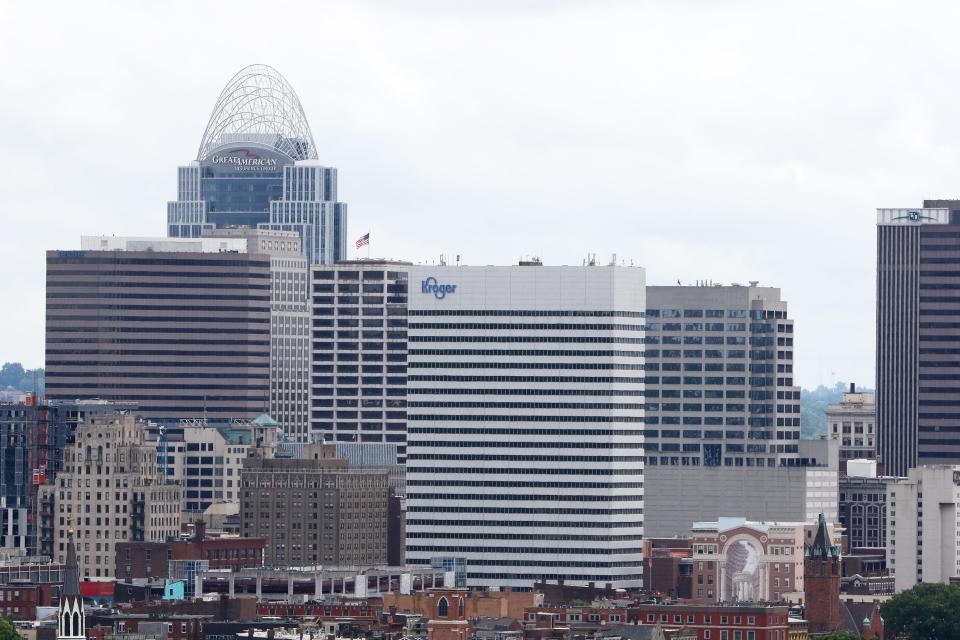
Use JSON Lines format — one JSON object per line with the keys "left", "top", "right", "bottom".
{"left": 627, "top": 604, "right": 790, "bottom": 640}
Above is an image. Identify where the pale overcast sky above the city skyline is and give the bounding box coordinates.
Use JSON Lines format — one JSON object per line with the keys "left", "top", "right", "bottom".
{"left": 7, "top": 0, "right": 960, "bottom": 387}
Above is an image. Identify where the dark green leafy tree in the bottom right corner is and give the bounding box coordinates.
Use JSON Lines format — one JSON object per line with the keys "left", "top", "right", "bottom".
{"left": 880, "top": 583, "right": 960, "bottom": 640}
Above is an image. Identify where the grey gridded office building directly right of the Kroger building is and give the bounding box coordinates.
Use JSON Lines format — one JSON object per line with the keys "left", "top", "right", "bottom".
{"left": 646, "top": 282, "right": 800, "bottom": 473}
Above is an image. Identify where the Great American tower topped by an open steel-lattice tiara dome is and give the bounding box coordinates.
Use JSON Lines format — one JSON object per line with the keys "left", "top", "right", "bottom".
{"left": 167, "top": 65, "right": 347, "bottom": 264}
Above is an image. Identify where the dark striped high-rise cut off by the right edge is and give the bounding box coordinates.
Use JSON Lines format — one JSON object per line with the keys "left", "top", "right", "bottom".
{"left": 877, "top": 200, "right": 960, "bottom": 476}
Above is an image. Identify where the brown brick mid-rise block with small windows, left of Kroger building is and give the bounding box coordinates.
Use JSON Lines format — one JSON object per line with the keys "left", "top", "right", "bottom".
{"left": 240, "top": 445, "right": 391, "bottom": 567}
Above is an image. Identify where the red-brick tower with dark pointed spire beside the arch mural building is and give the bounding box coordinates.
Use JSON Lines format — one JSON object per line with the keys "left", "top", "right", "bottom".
{"left": 803, "top": 513, "right": 840, "bottom": 633}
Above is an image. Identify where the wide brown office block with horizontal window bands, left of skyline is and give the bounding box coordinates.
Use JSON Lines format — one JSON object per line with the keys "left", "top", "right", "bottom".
{"left": 46, "top": 237, "right": 271, "bottom": 422}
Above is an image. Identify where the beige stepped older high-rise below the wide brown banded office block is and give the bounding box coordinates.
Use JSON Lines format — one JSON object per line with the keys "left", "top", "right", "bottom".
{"left": 54, "top": 414, "right": 181, "bottom": 577}
